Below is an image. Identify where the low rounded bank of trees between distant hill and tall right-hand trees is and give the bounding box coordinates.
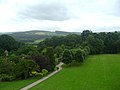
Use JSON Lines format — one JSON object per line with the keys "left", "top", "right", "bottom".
{"left": 38, "top": 34, "right": 82, "bottom": 51}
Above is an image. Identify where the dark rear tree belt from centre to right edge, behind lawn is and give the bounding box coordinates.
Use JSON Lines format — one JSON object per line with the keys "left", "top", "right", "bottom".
{"left": 38, "top": 30, "right": 120, "bottom": 54}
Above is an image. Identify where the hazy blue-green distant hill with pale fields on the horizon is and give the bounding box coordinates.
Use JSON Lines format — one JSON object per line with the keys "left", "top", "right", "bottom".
{"left": 4, "top": 30, "right": 80, "bottom": 44}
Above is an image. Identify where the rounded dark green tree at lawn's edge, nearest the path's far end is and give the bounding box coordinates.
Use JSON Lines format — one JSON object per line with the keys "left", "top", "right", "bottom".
{"left": 62, "top": 49, "right": 72, "bottom": 64}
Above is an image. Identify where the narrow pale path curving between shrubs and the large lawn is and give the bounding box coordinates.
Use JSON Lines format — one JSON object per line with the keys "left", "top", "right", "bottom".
{"left": 20, "top": 62, "right": 63, "bottom": 90}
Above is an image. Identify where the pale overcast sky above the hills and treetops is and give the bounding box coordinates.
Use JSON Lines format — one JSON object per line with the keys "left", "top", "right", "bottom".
{"left": 0, "top": 0, "right": 120, "bottom": 32}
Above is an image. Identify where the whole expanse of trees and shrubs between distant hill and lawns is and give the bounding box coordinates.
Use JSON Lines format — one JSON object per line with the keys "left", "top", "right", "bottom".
{"left": 0, "top": 30, "right": 120, "bottom": 81}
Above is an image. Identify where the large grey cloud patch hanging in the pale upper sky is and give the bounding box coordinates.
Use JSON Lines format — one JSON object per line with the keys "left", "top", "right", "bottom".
{"left": 20, "top": 3, "right": 71, "bottom": 21}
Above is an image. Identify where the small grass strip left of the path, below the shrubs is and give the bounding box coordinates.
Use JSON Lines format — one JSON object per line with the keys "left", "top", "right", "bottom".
{"left": 0, "top": 77, "right": 39, "bottom": 90}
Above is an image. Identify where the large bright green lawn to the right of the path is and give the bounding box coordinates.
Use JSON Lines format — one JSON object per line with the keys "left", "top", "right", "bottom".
{"left": 31, "top": 54, "right": 120, "bottom": 90}
